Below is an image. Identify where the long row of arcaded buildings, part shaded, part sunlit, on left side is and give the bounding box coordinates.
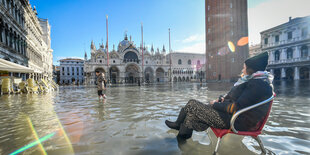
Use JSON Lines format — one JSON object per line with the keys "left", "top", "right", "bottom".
{"left": 0, "top": 0, "right": 53, "bottom": 80}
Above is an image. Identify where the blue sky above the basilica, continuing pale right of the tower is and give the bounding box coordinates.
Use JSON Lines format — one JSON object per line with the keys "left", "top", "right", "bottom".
{"left": 30, "top": 0, "right": 309, "bottom": 64}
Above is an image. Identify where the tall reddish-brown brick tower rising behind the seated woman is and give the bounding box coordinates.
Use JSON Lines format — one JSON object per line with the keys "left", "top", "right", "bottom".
{"left": 205, "top": 0, "right": 249, "bottom": 81}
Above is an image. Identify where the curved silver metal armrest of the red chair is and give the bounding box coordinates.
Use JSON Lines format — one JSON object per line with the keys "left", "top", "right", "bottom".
{"left": 230, "top": 94, "right": 275, "bottom": 133}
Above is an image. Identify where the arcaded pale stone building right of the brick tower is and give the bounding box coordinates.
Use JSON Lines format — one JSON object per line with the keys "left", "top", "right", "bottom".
{"left": 261, "top": 16, "right": 310, "bottom": 80}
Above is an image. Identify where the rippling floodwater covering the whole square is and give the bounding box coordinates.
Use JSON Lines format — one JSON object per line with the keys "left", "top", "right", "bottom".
{"left": 0, "top": 81, "right": 310, "bottom": 155}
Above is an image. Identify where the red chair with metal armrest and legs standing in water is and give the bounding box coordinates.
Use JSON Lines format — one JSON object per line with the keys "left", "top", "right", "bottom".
{"left": 211, "top": 94, "right": 275, "bottom": 154}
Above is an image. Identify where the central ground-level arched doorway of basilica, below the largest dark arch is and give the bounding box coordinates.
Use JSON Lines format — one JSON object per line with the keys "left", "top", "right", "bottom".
{"left": 125, "top": 63, "right": 140, "bottom": 83}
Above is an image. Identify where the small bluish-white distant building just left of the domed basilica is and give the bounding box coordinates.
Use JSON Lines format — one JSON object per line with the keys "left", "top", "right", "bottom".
{"left": 59, "top": 58, "right": 84, "bottom": 84}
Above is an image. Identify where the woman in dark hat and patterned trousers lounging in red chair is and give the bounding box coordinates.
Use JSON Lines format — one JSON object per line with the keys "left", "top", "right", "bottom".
{"left": 165, "top": 52, "right": 273, "bottom": 140}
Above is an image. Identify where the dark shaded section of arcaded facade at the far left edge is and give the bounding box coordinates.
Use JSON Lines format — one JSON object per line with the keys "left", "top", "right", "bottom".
{"left": 0, "top": 0, "right": 28, "bottom": 78}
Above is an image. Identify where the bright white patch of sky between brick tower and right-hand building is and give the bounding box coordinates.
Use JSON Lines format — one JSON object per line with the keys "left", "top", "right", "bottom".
{"left": 248, "top": 0, "right": 310, "bottom": 44}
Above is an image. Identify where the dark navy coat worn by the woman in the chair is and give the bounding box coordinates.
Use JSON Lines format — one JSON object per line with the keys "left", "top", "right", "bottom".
{"left": 213, "top": 79, "right": 273, "bottom": 131}
